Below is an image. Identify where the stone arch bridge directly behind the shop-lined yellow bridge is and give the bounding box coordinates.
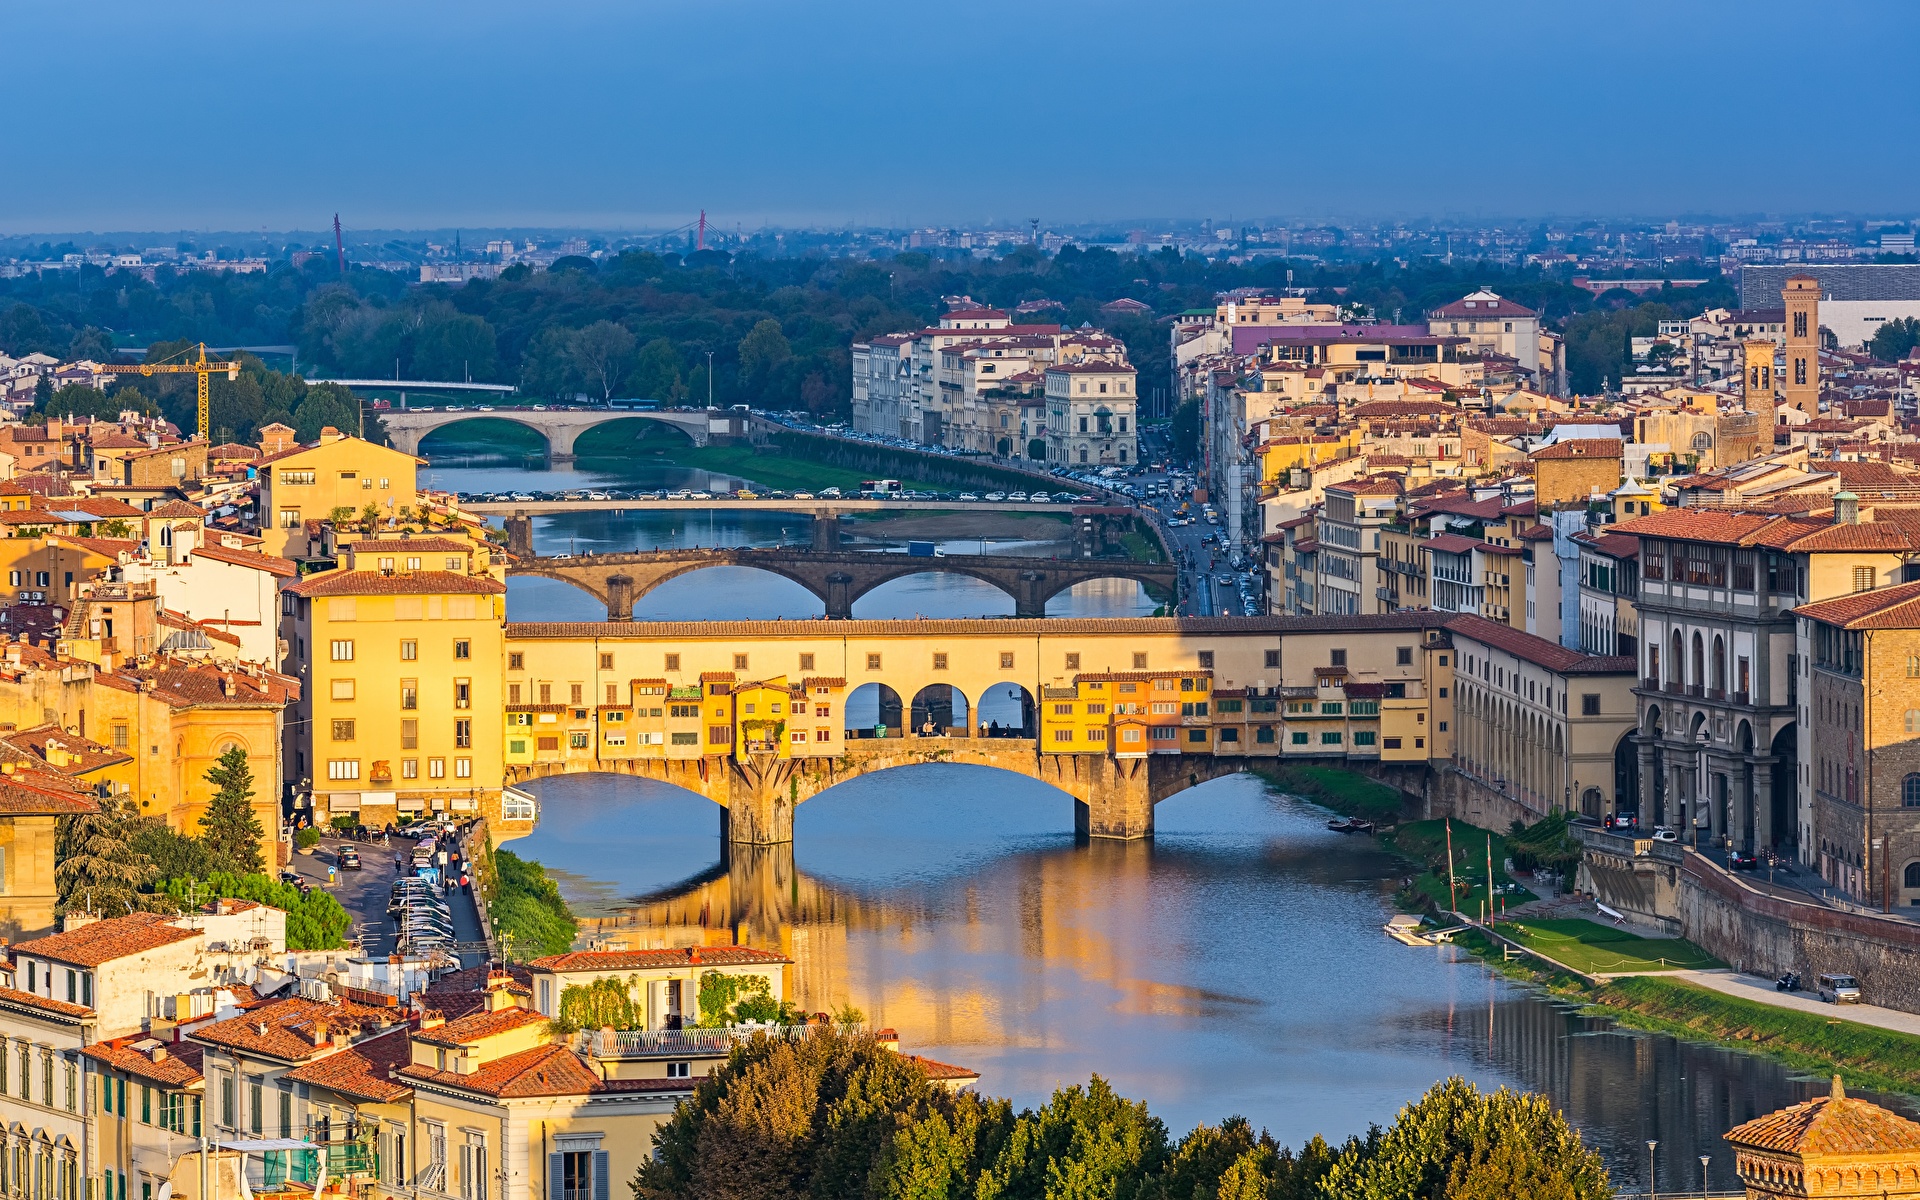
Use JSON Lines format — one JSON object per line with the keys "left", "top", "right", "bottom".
{"left": 507, "top": 541, "right": 1179, "bottom": 620}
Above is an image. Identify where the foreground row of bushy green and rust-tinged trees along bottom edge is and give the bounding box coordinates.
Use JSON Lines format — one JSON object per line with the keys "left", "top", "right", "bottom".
{"left": 632, "top": 1029, "right": 1611, "bottom": 1200}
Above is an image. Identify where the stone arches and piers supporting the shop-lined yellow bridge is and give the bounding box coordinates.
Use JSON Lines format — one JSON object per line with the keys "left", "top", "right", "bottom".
{"left": 507, "top": 737, "right": 1244, "bottom": 845}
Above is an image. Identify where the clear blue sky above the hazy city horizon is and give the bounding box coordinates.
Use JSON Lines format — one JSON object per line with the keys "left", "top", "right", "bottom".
{"left": 0, "top": 0, "right": 1920, "bottom": 234}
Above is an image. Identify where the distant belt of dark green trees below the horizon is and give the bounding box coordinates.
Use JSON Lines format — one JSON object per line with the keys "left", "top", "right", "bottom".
{"left": 0, "top": 246, "right": 1766, "bottom": 432}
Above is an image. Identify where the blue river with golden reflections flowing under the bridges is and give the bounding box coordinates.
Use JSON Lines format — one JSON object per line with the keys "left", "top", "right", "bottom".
{"left": 432, "top": 428, "right": 1858, "bottom": 1192}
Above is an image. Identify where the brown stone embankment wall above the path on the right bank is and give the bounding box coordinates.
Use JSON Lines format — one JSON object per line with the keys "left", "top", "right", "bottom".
{"left": 1576, "top": 829, "right": 1920, "bottom": 1012}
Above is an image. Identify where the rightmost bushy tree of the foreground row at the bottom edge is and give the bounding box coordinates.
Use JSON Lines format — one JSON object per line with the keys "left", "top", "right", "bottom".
{"left": 1319, "top": 1075, "right": 1613, "bottom": 1200}
